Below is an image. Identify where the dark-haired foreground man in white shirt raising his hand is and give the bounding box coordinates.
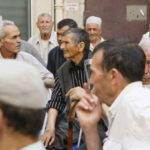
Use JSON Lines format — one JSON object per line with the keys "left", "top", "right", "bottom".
{"left": 76, "top": 41, "right": 150, "bottom": 150}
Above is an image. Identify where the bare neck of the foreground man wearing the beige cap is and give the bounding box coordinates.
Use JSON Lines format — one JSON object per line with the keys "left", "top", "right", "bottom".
{"left": 0, "top": 131, "right": 37, "bottom": 150}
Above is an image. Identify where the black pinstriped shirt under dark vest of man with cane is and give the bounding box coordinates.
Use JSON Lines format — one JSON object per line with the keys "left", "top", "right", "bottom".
{"left": 47, "top": 58, "right": 87, "bottom": 112}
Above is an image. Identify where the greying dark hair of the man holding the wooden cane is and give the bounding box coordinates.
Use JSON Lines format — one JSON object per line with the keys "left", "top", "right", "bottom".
{"left": 63, "top": 28, "right": 90, "bottom": 53}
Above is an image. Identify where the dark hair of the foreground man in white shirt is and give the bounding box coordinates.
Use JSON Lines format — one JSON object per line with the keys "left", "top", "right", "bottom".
{"left": 94, "top": 40, "right": 145, "bottom": 82}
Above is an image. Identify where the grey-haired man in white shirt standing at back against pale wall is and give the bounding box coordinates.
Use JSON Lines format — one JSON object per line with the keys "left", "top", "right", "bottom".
{"left": 28, "top": 13, "right": 58, "bottom": 64}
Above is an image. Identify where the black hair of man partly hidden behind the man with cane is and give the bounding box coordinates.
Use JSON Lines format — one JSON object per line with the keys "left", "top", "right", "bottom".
{"left": 57, "top": 19, "right": 78, "bottom": 29}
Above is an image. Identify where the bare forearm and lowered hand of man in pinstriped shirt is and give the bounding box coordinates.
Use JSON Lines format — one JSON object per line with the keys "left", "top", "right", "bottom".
{"left": 40, "top": 108, "right": 58, "bottom": 147}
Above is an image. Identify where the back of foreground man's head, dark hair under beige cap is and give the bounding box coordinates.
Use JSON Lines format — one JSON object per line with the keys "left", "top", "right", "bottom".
{"left": 0, "top": 60, "right": 46, "bottom": 137}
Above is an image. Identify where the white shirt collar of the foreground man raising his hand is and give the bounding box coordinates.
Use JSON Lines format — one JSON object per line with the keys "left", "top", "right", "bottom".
{"left": 107, "top": 81, "right": 143, "bottom": 122}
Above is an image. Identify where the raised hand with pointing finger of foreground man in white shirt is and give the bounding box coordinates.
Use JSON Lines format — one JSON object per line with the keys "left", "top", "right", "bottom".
{"left": 76, "top": 84, "right": 102, "bottom": 130}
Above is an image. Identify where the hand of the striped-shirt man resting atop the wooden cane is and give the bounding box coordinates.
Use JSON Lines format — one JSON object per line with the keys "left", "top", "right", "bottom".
{"left": 66, "top": 87, "right": 86, "bottom": 101}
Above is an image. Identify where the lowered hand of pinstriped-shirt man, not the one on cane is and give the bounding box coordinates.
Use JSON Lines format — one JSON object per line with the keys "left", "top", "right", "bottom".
{"left": 40, "top": 129, "right": 55, "bottom": 147}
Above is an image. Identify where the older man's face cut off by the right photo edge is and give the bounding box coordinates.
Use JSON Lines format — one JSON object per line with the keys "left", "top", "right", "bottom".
{"left": 142, "top": 46, "right": 150, "bottom": 85}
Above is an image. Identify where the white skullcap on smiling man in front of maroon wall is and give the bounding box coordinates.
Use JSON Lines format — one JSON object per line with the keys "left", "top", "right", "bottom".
{"left": 86, "top": 16, "right": 102, "bottom": 27}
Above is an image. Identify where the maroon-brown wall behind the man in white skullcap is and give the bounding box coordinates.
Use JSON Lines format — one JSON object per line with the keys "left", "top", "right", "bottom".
{"left": 84, "top": 0, "right": 150, "bottom": 42}
